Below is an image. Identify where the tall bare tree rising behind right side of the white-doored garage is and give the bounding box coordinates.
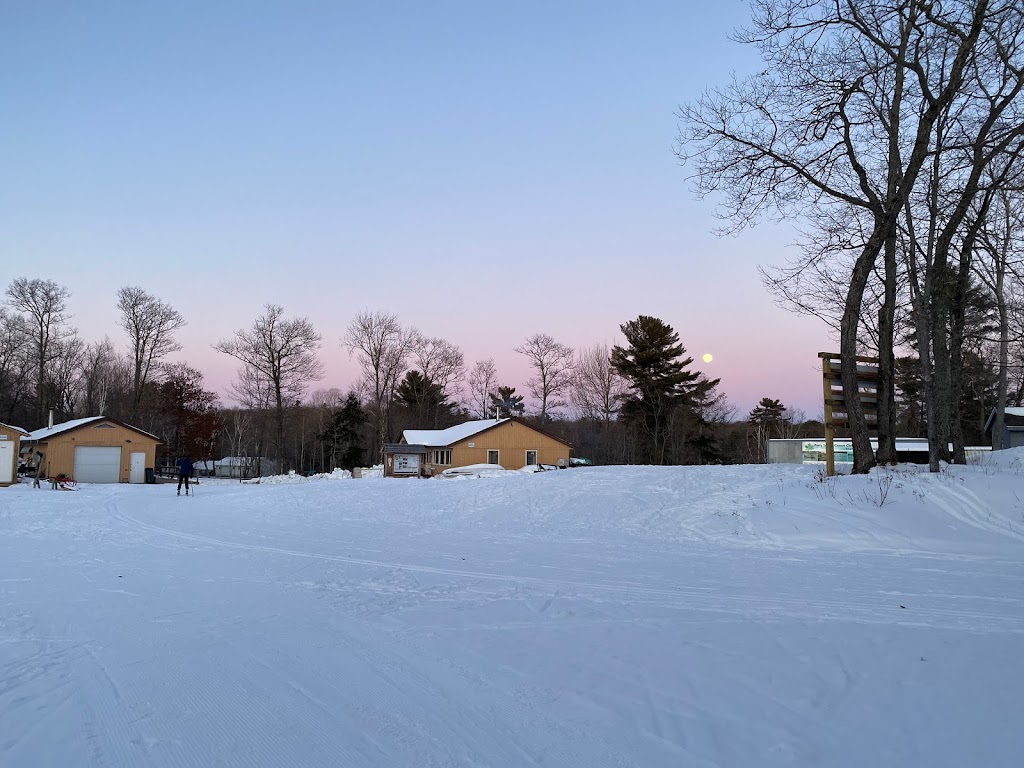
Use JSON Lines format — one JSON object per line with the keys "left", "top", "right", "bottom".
{"left": 118, "top": 286, "right": 185, "bottom": 419}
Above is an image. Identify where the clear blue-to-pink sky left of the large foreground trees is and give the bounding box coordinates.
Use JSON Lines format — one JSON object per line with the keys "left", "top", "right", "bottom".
{"left": 0, "top": 0, "right": 834, "bottom": 415}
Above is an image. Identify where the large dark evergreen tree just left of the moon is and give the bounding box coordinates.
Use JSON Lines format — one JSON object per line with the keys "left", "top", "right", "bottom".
{"left": 611, "top": 314, "right": 719, "bottom": 464}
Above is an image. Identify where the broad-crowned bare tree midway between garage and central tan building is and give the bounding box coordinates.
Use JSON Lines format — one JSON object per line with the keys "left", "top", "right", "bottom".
{"left": 213, "top": 304, "right": 324, "bottom": 471}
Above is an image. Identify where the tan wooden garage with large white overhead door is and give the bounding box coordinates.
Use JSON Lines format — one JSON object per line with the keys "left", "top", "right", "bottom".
{"left": 24, "top": 416, "right": 161, "bottom": 482}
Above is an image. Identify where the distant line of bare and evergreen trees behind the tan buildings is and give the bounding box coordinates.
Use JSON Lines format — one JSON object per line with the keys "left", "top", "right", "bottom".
{"left": 0, "top": 278, "right": 1011, "bottom": 472}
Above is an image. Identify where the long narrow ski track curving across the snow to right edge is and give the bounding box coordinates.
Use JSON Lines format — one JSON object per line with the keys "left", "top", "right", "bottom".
{"left": 114, "top": 511, "right": 1024, "bottom": 633}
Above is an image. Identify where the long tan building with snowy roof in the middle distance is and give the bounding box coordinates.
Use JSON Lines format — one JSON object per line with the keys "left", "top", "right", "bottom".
{"left": 384, "top": 419, "right": 572, "bottom": 477}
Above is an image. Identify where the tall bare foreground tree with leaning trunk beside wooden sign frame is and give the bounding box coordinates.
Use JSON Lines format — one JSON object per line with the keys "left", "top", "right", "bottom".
{"left": 680, "top": 0, "right": 1022, "bottom": 472}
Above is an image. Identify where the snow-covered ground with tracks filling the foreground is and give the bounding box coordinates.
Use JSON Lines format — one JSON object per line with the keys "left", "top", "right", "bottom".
{"left": 0, "top": 451, "right": 1024, "bottom": 768}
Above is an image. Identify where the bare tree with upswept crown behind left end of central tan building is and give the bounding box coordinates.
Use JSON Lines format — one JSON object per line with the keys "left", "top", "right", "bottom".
{"left": 342, "top": 310, "right": 421, "bottom": 456}
